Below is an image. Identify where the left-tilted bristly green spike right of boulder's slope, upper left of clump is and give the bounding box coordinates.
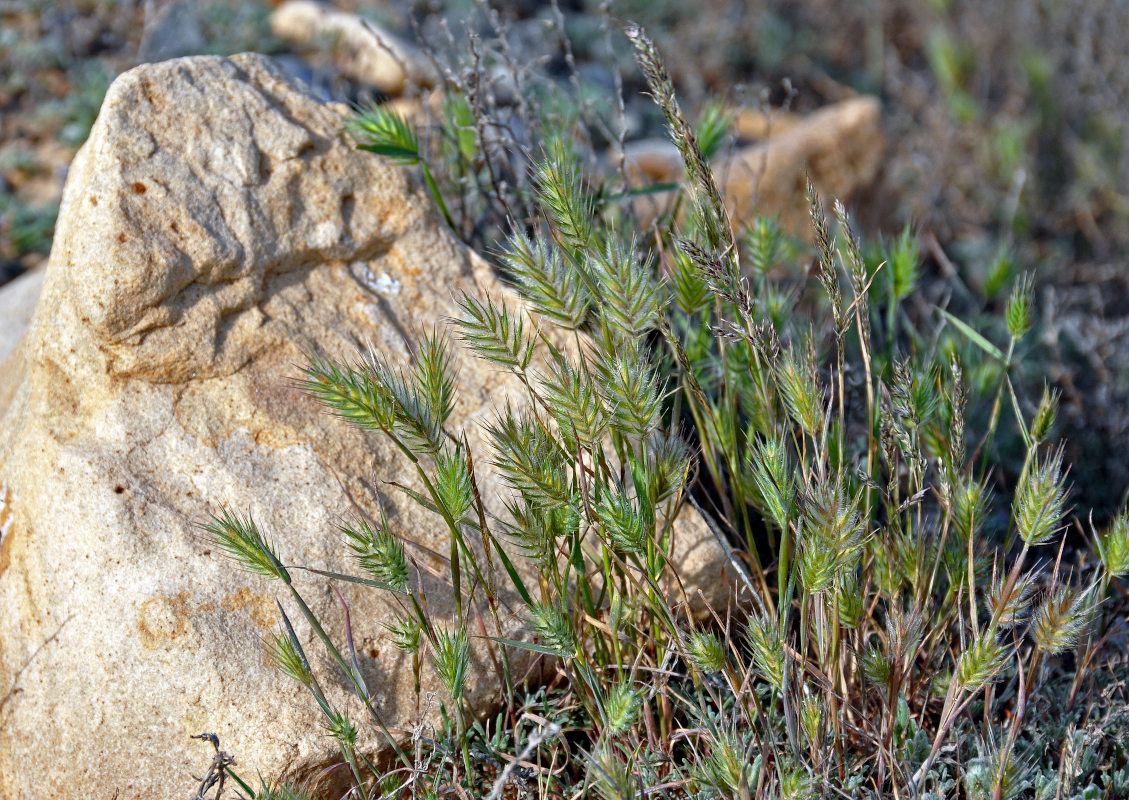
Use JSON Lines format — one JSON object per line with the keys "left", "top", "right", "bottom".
{"left": 499, "top": 231, "right": 592, "bottom": 329}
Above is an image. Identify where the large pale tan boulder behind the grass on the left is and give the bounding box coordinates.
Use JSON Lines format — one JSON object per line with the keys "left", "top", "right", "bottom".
{"left": 0, "top": 55, "right": 724, "bottom": 800}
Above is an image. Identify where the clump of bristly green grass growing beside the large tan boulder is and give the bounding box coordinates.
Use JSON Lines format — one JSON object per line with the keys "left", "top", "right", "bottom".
{"left": 208, "top": 17, "right": 1129, "bottom": 798}
